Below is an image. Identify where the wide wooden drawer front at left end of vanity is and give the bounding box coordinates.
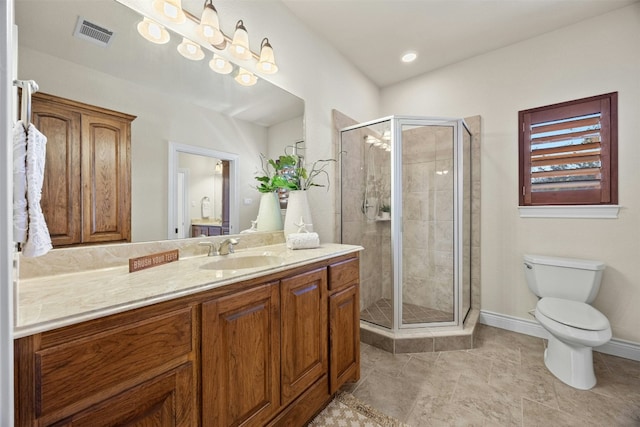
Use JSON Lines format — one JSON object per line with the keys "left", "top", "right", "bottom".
{"left": 35, "top": 307, "right": 193, "bottom": 416}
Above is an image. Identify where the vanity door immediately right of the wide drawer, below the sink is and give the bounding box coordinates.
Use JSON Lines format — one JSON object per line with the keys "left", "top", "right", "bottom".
{"left": 202, "top": 282, "right": 280, "bottom": 427}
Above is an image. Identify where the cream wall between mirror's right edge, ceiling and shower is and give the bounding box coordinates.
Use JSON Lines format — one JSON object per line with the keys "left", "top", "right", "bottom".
{"left": 216, "top": 1, "right": 379, "bottom": 242}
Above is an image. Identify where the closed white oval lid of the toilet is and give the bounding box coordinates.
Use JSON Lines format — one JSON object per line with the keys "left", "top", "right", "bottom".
{"left": 537, "top": 297, "right": 609, "bottom": 331}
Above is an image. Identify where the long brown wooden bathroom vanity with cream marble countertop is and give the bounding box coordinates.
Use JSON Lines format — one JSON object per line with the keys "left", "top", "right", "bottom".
{"left": 15, "top": 244, "right": 361, "bottom": 426}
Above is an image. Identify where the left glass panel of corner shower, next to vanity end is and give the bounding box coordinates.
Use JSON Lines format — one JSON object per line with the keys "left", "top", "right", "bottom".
{"left": 340, "top": 119, "right": 394, "bottom": 329}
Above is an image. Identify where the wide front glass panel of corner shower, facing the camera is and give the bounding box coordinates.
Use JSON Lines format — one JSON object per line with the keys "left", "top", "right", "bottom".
{"left": 395, "top": 119, "right": 457, "bottom": 327}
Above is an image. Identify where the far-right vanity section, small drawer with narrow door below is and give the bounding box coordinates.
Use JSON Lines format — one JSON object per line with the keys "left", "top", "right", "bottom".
{"left": 329, "top": 258, "right": 360, "bottom": 394}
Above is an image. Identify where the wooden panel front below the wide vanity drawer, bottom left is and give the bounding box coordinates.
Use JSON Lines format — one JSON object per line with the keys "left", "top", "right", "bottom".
{"left": 51, "top": 362, "right": 192, "bottom": 427}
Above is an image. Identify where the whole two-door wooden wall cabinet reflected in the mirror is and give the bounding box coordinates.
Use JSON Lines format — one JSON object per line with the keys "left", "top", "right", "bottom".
{"left": 32, "top": 93, "right": 135, "bottom": 247}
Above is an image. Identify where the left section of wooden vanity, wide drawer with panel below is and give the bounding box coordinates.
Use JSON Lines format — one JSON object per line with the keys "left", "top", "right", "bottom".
{"left": 15, "top": 304, "right": 198, "bottom": 426}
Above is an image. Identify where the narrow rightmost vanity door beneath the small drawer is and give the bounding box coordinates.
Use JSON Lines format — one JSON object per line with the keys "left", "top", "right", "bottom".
{"left": 329, "top": 284, "right": 360, "bottom": 394}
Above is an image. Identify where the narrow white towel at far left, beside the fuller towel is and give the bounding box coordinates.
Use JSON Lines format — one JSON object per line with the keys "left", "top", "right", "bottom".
{"left": 13, "top": 121, "right": 29, "bottom": 243}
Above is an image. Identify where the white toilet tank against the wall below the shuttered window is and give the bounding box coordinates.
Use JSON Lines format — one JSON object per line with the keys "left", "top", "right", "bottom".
{"left": 524, "top": 255, "right": 605, "bottom": 303}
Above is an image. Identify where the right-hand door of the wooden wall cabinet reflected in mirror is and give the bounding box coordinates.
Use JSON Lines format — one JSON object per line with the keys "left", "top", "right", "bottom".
{"left": 82, "top": 113, "right": 131, "bottom": 243}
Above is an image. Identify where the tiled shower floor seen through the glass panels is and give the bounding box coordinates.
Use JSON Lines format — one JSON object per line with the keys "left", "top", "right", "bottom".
{"left": 360, "top": 298, "right": 453, "bottom": 328}
